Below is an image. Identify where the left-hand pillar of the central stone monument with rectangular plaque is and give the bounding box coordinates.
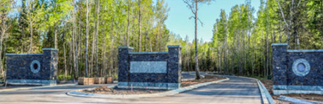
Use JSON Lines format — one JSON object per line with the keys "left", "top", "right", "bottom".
{"left": 118, "top": 47, "right": 133, "bottom": 86}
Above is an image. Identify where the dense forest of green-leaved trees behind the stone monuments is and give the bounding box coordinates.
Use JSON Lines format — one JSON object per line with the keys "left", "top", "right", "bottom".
{"left": 0, "top": 0, "right": 323, "bottom": 80}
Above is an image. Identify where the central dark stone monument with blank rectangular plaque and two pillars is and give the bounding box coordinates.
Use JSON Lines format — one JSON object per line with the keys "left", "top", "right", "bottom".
{"left": 118, "top": 45, "right": 182, "bottom": 89}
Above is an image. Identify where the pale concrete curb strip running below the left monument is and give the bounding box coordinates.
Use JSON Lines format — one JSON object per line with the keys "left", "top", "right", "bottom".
{"left": 0, "top": 84, "right": 77, "bottom": 92}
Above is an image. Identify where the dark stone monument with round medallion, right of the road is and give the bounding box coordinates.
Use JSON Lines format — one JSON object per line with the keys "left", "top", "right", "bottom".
{"left": 272, "top": 43, "right": 323, "bottom": 95}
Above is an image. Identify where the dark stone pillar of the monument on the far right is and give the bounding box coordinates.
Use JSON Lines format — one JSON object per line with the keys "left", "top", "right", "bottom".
{"left": 271, "top": 43, "right": 288, "bottom": 92}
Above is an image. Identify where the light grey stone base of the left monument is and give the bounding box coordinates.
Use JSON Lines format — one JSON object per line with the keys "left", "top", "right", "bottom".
{"left": 6, "top": 79, "right": 57, "bottom": 86}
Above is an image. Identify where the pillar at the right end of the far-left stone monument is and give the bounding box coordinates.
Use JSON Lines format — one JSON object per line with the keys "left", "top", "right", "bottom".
{"left": 43, "top": 48, "right": 58, "bottom": 85}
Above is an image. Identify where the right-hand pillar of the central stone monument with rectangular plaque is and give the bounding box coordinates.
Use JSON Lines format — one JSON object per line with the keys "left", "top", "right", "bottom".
{"left": 167, "top": 45, "right": 182, "bottom": 89}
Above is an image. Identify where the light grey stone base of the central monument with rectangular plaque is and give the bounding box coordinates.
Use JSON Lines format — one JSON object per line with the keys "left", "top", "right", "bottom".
{"left": 118, "top": 82, "right": 181, "bottom": 89}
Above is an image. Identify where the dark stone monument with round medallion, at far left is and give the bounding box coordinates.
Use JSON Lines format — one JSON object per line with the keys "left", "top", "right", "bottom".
{"left": 6, "top": 48, "right": 58, "bottom": 85}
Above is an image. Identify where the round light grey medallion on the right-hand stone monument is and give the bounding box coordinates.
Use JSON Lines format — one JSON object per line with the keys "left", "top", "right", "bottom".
{"left": 292, "top": 59, "right": 311, "bottom": 77}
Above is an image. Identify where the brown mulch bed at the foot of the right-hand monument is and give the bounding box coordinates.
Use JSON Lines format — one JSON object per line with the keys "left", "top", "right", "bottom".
{"left": 260, "top": 79, "right": 323, "bottom": 101}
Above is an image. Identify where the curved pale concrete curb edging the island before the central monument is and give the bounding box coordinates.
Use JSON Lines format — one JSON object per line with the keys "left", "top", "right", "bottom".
{"left": 66, "top": 78, "right": 230, "bottom": 98}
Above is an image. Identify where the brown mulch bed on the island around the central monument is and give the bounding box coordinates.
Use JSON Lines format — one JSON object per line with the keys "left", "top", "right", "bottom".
{"left": 80, "top": 76, "right": 225, "bottom": 95}
